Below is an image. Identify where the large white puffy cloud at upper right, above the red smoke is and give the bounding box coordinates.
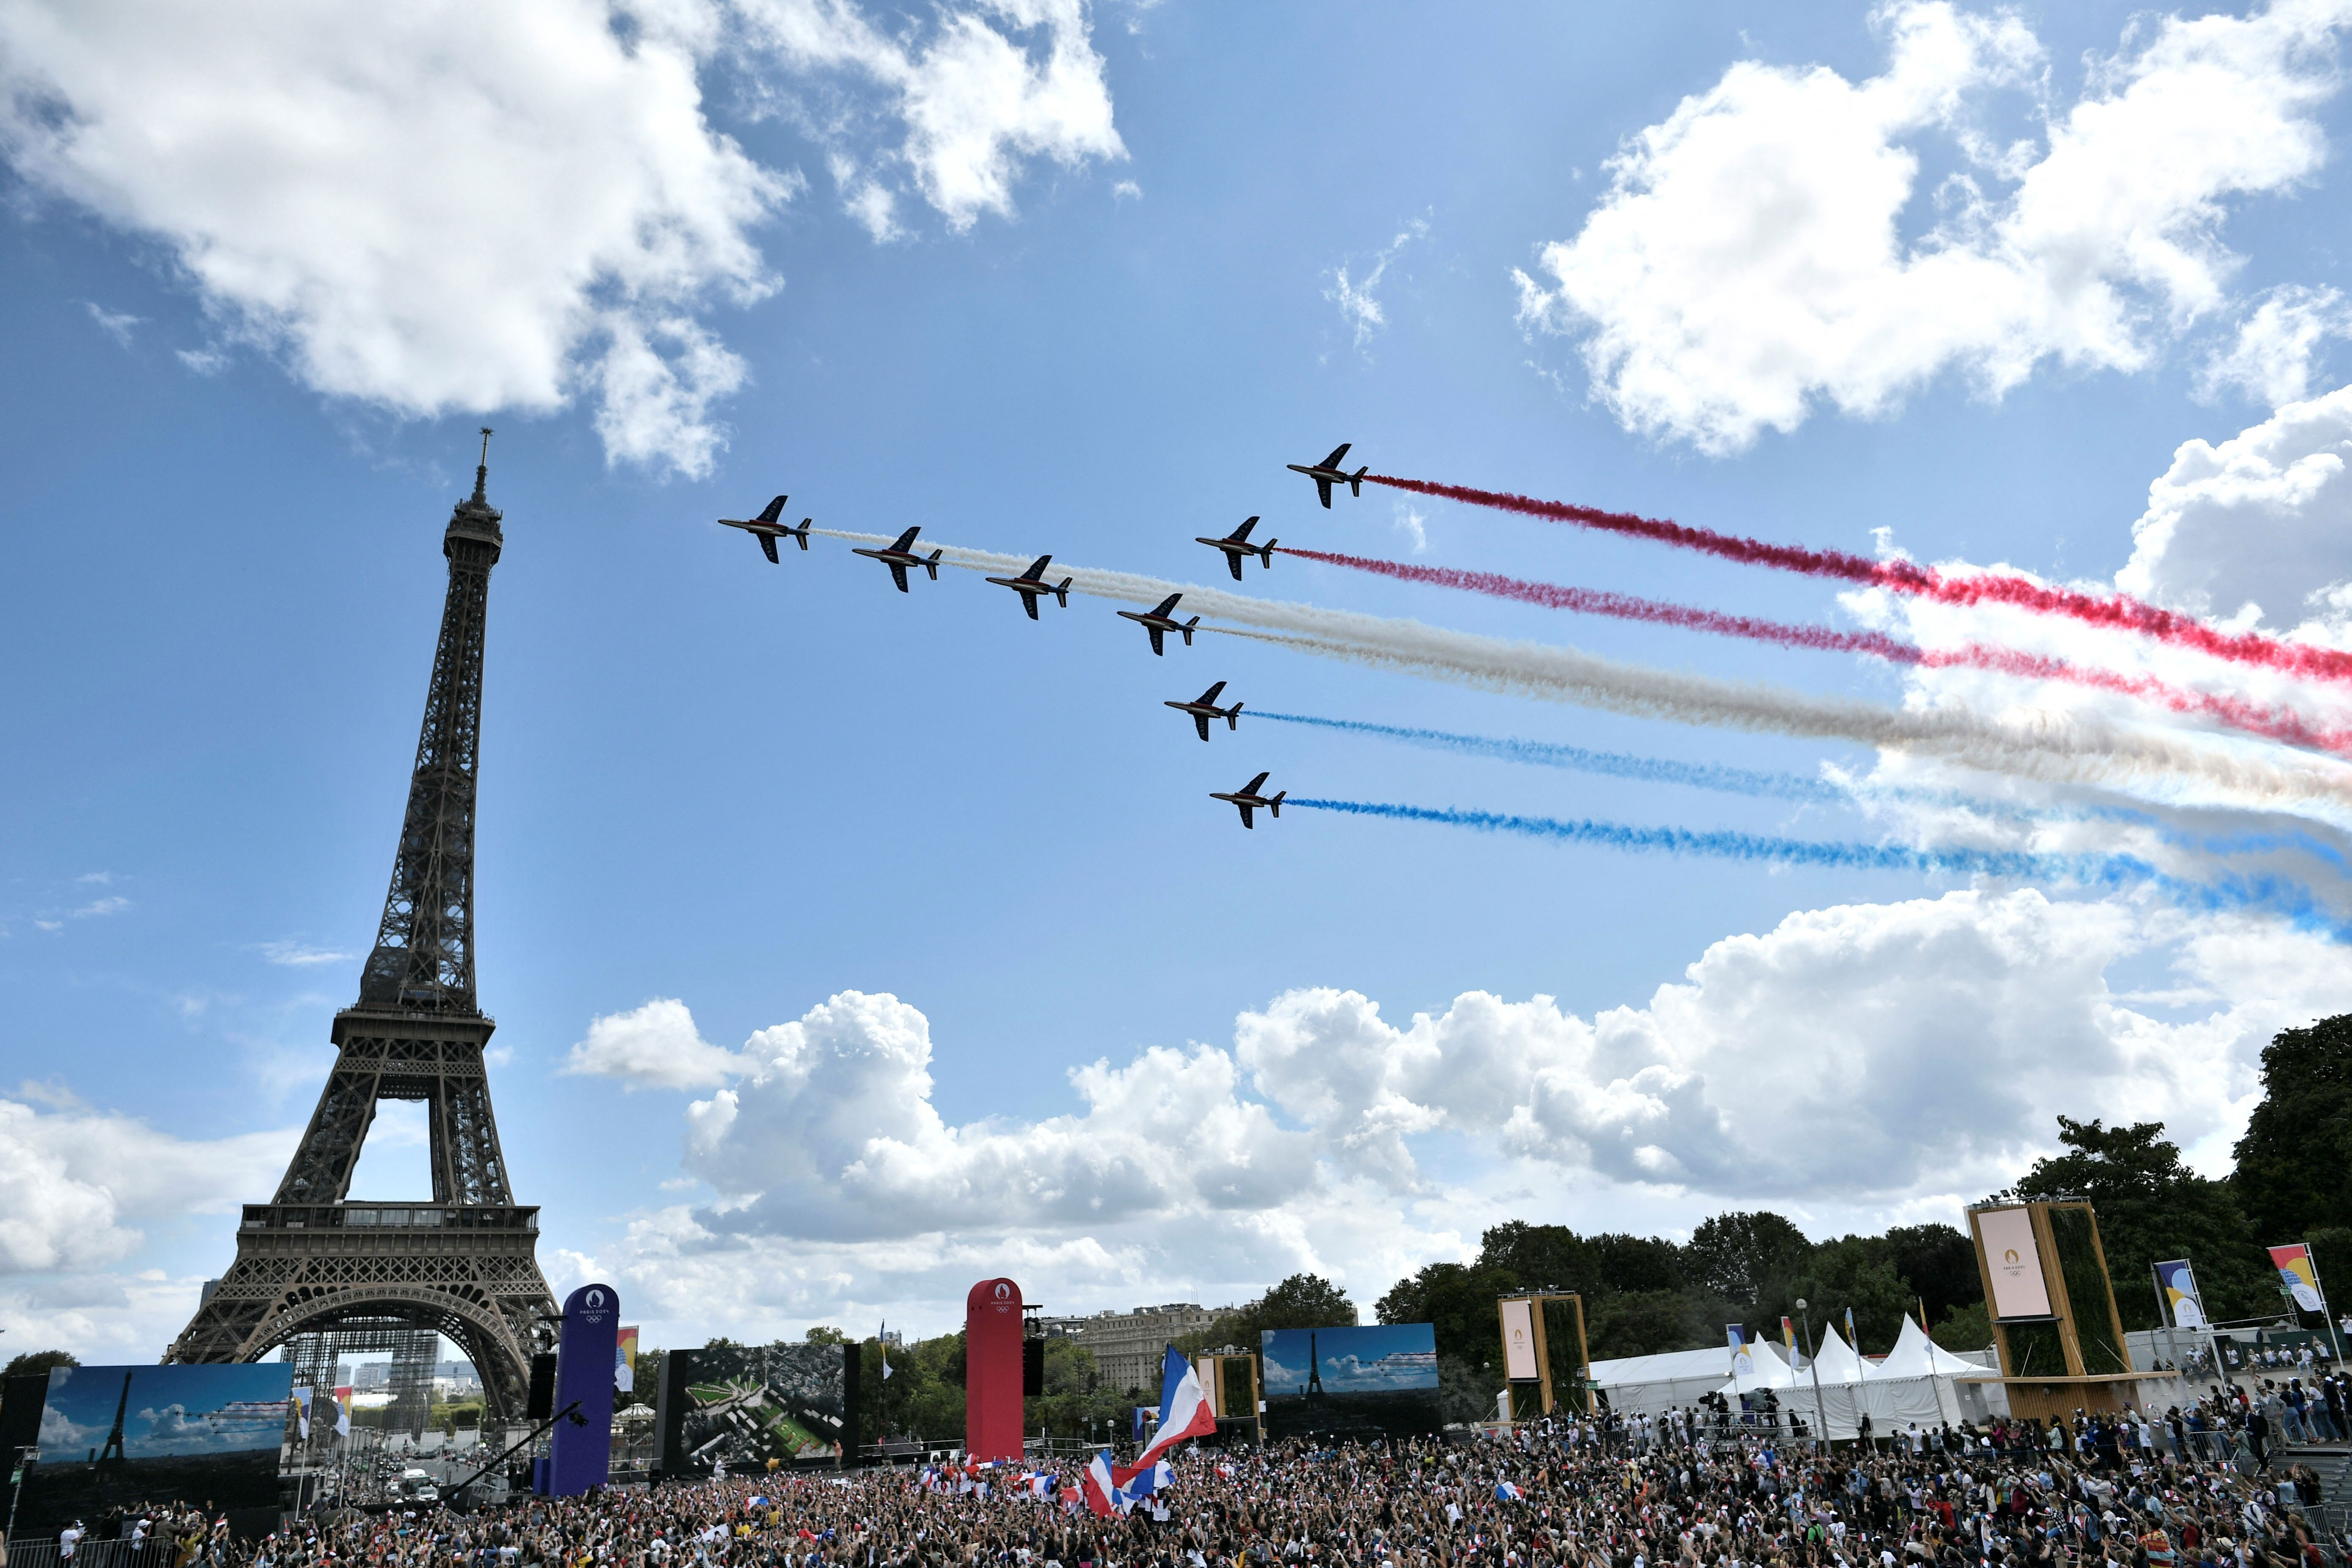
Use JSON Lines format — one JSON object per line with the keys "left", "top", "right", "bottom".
{"left": 1517, "top": 0, "right": 2352, "bottom": 454}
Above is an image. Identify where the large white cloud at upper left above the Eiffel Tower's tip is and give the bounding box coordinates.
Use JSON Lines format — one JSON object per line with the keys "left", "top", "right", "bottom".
{"left": 0, "top": 0, "right": 788, "bottom": 473}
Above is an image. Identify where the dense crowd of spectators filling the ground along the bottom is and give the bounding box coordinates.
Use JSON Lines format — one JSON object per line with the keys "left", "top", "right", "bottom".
{"left": 18, "top": 1389, "right": 2352, "bottom": 1568}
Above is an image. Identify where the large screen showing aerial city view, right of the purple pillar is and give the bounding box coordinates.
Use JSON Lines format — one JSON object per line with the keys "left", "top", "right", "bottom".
{"left": 661, "top": 1345, "right": 856, "bottom": 1476}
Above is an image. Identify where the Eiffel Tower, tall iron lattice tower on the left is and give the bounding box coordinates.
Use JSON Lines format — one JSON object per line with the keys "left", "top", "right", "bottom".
{"left": 165, "top": 430, "right": 555, "bottom": 1436}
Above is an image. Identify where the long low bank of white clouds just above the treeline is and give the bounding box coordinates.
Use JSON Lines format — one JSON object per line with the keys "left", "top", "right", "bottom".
{"left": 572, "top": 889, "right": 2352, "bottom": 1335}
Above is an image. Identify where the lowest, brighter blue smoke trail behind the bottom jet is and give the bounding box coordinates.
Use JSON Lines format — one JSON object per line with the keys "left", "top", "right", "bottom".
{"left": 1284, "top": 795, "right": 2352, "bottom": 943}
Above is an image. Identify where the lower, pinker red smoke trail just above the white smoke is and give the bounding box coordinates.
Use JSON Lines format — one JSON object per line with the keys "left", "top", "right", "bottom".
{"left": 1277, "top": 545, "right": 2352, "bottom": 757}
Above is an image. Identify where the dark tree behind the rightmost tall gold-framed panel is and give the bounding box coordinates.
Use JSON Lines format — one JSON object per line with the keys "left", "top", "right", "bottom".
{"left": 2009, "top": 1116, "right": 2279, "bottom": 1328}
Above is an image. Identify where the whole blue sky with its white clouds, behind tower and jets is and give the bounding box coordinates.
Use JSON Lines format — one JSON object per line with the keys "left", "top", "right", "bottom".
{"left": 0, "top": 0, "right": 2352, "bottom": 1359}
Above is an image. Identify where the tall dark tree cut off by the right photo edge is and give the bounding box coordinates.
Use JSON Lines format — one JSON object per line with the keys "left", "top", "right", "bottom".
{"left": 2199, "top": 1013, "right": 2352, "bottom": 1250}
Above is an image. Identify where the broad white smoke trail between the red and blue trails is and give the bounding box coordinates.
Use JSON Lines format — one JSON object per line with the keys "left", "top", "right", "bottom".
{"left": 814, "top": 529, "right": 2352, "bottom": 806}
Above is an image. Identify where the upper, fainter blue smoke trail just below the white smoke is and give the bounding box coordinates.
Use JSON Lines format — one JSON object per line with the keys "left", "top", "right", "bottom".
{"left": 1249, "top": 708, "right": 2352, "bottom": 870}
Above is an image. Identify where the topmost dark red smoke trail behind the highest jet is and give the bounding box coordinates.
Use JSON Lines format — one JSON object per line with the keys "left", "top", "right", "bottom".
{"left": 1364, "top": 475, "right": 2352, "bottom": 682}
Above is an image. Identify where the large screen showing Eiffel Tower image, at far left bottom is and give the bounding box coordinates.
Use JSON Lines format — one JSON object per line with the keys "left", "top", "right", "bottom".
{"left": 16, "top": 1361, "right": 294, "bottom": 1535}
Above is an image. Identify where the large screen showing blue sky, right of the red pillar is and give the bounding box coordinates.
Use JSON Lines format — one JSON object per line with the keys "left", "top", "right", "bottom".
{"left": 1258, "top": 1323, "right": 1444, "bottom": 1441}
